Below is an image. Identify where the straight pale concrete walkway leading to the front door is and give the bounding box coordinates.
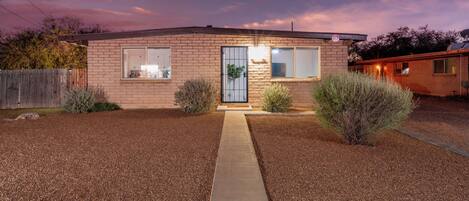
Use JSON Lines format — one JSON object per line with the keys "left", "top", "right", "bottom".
{"left": 210, "top": 111, "right": 268, "bottom": 201}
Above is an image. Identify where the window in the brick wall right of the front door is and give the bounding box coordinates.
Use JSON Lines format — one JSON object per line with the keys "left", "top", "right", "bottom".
{"left": 272, "top": 47, "right": 319, "bottom": 78}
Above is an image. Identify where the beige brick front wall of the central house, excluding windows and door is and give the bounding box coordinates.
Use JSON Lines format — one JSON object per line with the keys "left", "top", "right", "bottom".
{"left": 88, "top": 34, "right": 347, "bottom": 108}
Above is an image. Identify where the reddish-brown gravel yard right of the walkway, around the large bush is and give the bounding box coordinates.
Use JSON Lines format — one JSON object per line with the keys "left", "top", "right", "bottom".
{"left": 248, "top": 116, "right": 469, "bottom": 201}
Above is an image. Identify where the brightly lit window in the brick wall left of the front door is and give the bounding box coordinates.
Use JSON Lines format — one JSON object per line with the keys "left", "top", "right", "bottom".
{"left": 123, "top": 48, "right": 171, "bottom": 79}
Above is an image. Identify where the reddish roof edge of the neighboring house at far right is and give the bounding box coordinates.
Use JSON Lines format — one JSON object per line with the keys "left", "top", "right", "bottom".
{"left": 357, "top": 49, "right": 469, "bottom": 65}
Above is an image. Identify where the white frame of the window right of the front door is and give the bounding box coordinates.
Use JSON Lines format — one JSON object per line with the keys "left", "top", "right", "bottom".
{"left": 270, "top": 46, "right": 322, "bottom": 80}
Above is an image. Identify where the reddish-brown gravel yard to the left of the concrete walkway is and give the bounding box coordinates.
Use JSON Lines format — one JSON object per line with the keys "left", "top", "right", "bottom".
{"left": 0, "top": 110, "right": 224, "bottom": 200}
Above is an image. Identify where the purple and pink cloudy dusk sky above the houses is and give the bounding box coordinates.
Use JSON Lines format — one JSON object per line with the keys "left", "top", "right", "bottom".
{"left": 0, "top": 0, "right": 469, "bottom": 37}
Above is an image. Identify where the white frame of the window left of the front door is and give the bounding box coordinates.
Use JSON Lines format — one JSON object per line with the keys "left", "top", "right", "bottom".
{"left": 120, "top": 46, "right": 173, "bottom": 81}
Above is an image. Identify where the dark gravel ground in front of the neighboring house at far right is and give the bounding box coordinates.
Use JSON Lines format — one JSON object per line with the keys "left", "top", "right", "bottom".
{"left": 405, "top": 96, "right": 469, "bottom": 152}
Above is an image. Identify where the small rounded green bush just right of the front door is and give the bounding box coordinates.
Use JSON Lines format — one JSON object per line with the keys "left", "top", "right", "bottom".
{"left": 262, "top": 83, "right": 292, "bottom": 112}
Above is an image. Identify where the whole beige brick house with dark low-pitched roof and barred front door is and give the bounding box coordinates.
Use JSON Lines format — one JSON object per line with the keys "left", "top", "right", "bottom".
{"left": 63, "top": 26, "right": 366, "bottom": 108}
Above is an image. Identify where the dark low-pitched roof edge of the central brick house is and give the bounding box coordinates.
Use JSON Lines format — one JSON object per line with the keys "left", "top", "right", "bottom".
{"left": 60, "top": 26, "right": 367, "bottom": 42}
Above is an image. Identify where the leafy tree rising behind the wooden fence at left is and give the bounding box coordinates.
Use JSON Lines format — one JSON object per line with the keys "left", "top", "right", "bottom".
{"left": 0, "top": 17, "right": 106, "bottom": 69}
